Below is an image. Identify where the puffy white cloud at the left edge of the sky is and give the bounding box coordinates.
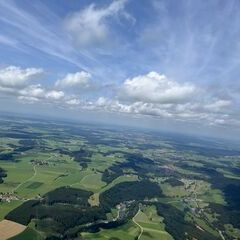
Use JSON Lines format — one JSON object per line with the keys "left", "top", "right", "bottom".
{"left": 0, "top": 66, "right": 43, "bottom": 88}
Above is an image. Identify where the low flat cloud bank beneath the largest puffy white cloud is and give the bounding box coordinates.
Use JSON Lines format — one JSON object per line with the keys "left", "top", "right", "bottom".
{"left": 92, "top": 97, "right": 236, "bottom": 126}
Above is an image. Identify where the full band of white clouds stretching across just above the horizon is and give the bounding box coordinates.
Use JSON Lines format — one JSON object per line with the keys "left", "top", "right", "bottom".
{"left": 0, "top": 66, "right": 240, "bottom": 130}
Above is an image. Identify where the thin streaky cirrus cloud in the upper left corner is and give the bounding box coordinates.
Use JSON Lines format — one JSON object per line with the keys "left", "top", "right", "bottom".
{"left": 0, "top": 1, "right": 93, "bottom": 69}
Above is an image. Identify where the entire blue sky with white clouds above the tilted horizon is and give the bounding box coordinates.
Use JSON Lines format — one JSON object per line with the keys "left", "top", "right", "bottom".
{"left": 0, "top": 0, "right": 240, "bottom": 139}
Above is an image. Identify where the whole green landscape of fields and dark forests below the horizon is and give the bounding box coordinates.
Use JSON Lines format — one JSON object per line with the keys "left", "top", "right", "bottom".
{"left": 0, "top": 116, "right": 240, "bottom": 240}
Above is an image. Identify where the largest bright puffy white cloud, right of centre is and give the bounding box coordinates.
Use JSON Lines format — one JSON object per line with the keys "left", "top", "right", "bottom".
{"left": 121, "top": 72, "right": 196, "bottom": 103}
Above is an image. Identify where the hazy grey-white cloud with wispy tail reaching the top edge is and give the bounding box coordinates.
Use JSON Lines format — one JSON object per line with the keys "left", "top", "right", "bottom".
{"left": 64, "top": 0, "right": 127, "bottom": 47}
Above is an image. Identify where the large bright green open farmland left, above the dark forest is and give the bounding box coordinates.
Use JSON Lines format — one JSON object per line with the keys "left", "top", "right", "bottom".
{"left": 0, "top": 153, "right": 89, "bottom": 199}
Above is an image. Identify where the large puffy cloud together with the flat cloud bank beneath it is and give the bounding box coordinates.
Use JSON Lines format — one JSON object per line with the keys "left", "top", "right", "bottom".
{"left": 85, "top": 72, "right": 236, "bottom": 126}
